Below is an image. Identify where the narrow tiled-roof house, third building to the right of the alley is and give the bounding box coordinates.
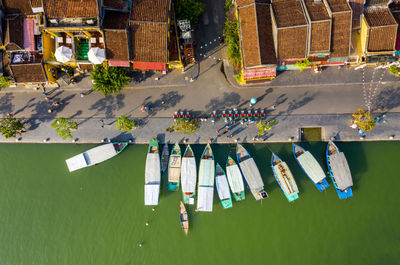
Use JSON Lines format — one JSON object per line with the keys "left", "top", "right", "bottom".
{"left": 303, "top": 0, "right": 332, "bottom": 56}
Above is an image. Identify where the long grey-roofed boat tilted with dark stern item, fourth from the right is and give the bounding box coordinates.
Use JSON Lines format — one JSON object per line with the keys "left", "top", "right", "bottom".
{"left": 236, "top": 143, "right": 268, "bottom": 201}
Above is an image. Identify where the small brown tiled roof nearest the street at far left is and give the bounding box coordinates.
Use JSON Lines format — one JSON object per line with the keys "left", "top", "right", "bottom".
{"left": 10, "top": 63, "right": 46, "bottom": 83}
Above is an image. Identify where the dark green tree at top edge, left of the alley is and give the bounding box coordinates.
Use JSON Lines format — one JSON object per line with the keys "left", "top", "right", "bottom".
{"left": 174, "top": 0, "right": 206, "bottom": 25}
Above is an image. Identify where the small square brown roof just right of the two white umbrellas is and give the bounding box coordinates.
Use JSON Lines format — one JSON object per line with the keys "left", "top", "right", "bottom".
{"left": 104, "top": 29, "right": 129, "bottom": 61}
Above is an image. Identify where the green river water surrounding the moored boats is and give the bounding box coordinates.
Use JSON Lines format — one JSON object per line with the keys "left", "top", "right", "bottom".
{"left": 0, "top": 142, "right": 400, "bottom": 265}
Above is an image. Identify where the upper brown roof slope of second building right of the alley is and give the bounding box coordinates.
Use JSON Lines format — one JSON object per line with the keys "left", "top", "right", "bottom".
{"left": 272, "top": 0, "right": 307, "bottom": 28}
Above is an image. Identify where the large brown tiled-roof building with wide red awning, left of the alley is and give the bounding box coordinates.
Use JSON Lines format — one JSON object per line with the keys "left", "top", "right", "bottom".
{"left": 129, "top": 0, "right": 170, "bottom": 71}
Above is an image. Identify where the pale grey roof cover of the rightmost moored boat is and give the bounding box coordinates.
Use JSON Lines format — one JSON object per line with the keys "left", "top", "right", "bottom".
{"left": 329, "top": 152, "right": 353, "bottom": 190}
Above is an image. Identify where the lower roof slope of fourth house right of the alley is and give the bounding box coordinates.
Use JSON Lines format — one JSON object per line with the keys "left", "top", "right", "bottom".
{"left": 331, "top": 12, "right": 352, "bottom": 57}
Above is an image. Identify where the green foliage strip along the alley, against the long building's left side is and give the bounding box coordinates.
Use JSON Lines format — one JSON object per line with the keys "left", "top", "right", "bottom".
{"left": 224, "top": 18, "right": 242, "bottom": 71}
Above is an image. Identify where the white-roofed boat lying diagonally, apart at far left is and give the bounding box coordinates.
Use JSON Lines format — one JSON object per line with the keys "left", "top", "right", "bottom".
{"left": 65, "top": 143, "right": 128, "bottom": 172}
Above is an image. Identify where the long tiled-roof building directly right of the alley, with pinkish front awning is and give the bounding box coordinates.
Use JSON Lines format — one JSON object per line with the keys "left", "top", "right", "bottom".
{"left": 237, "top": 0, "right": 276, "bottom": 83}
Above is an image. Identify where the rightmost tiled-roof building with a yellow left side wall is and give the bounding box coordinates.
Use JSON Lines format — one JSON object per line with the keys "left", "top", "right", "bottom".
{"left": 361, "top": 6, "right": 398, "bottom": 55}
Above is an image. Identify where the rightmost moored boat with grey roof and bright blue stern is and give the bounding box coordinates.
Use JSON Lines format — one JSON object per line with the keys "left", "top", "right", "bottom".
{"left": 326, "top": 141, "right": 353, "bottom": 199}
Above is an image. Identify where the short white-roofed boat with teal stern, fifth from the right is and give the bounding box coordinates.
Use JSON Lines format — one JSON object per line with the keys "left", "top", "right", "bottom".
{"left": 226, "top": 156, "right": 245, "bottom": 201}
